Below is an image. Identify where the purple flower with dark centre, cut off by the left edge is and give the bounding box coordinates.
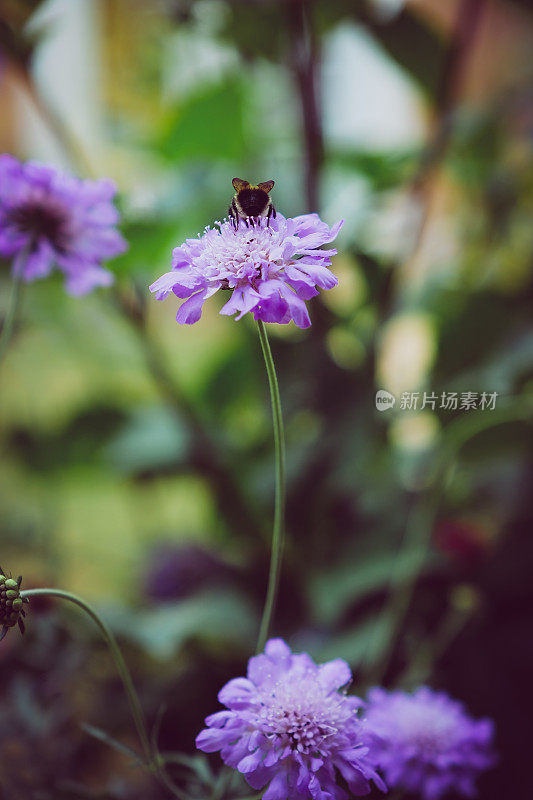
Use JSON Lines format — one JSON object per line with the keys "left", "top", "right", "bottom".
{"left": 0, "top": 153, "right": 127, "bottom": 295}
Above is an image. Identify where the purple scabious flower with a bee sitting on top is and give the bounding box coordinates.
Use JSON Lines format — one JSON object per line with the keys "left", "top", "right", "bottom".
{"left": 150, "top": 214, "right": 342, "bottom": 328}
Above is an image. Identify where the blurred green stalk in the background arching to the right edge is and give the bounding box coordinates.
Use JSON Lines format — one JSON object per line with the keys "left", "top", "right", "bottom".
{"left": 363, "top": 400, "right": 533, "bottom": 683}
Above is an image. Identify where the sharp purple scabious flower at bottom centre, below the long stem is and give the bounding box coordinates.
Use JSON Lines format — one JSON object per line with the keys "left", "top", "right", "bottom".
{"left": 196, "top": 639, "right": 386, "bottom": 800}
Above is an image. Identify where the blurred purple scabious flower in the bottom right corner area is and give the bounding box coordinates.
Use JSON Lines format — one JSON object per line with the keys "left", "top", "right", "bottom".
{"left": 365, "top": 686, "right": 495, "bottom": 800}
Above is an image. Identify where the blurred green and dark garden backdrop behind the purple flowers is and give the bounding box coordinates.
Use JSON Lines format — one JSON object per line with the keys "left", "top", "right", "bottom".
{"left": 0, "top": 0, "right": 533, "bottom": 800}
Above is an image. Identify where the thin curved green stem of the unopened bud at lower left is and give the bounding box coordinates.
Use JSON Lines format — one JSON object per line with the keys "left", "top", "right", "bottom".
{"left": 20, "top": 589, "right": 153, "bottom": 765}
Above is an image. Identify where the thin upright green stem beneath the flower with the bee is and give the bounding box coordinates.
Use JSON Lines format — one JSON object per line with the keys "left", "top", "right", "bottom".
{"left": 257, "top": 320, "right": 285, "bottom": 653}
